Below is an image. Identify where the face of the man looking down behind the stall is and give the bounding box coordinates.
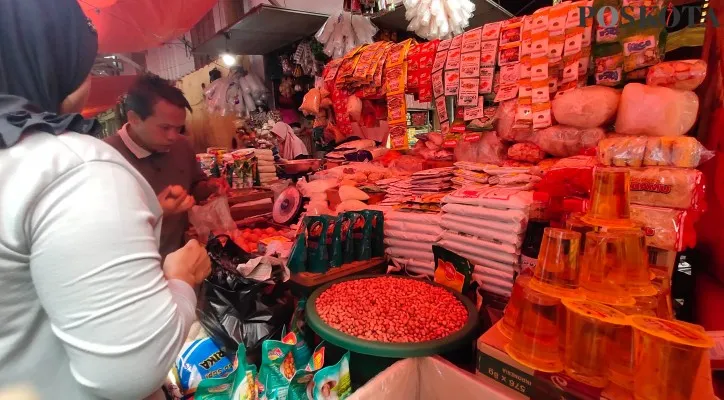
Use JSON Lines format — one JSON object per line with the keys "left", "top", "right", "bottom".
{"left": 128, "top": 99, "right": 186, "bottom": 153}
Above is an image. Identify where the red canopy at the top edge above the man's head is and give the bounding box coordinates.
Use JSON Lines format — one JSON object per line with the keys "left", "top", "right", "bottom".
{"left": 78, "top": 0, "right": 218, "bottom": 54}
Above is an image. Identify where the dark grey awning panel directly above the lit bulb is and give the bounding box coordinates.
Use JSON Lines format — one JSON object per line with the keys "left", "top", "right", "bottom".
{"left": 194, "top": 5, "right": 327, "bottom": 56}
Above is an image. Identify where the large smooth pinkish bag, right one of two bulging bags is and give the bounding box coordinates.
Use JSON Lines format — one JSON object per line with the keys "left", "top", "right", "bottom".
{"left": 616, "top": 83, "right": 699, "bottom": 136}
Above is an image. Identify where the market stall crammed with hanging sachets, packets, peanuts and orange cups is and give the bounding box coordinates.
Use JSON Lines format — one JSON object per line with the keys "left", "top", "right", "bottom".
{"left": 177, "top": 1, "right": 714, "bottom": 399}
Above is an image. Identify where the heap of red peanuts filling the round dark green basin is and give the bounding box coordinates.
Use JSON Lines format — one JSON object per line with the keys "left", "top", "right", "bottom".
{"left": 316, "top": 277, "right": 468, "bottom": 343}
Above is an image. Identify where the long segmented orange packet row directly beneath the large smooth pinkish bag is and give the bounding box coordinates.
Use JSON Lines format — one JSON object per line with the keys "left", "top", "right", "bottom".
{"left": 598, "top": 136, "right": 714, "bottom": 168}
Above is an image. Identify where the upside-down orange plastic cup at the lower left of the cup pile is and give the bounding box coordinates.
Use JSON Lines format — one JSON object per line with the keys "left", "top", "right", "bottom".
{"left": 505, "top": 281, "right": 563, "bottom": 372}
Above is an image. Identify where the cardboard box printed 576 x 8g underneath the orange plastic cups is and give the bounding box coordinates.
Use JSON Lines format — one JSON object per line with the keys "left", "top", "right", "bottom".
{"left": 475, "top": 326, "right": 717, "bottom": 400}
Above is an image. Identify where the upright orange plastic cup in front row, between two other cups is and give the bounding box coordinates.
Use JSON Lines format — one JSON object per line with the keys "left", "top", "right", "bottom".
{"left": 563, "top": 299, "right": 628, "bottom": 388}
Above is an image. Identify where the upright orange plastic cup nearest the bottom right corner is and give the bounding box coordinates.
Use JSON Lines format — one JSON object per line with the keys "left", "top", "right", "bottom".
{"left": 629, "top": 315, "right": 714, "bottom": 400}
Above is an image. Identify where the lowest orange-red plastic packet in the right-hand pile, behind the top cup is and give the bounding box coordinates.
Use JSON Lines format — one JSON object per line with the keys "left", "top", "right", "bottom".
{"left": 630, "top": 204, "right": 697, "bottom": 251}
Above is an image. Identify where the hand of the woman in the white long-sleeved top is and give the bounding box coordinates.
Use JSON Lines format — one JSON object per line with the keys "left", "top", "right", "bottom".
{"left": 163, "top": 239, "right": 211, "bottom": 287}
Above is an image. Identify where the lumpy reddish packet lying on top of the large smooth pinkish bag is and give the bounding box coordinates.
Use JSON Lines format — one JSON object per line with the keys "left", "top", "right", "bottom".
{"left": 646, "top": 60, "right": 706, "bottom": 90}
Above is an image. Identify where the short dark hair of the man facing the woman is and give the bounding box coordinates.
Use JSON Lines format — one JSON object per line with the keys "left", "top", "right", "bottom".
{"left": 125, "top": 74, "right": 193, "bottom": 120}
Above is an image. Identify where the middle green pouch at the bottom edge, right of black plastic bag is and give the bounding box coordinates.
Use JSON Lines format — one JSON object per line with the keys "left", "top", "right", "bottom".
{"left": 257, "top": 335, "right": 296, "bottom": 400}
